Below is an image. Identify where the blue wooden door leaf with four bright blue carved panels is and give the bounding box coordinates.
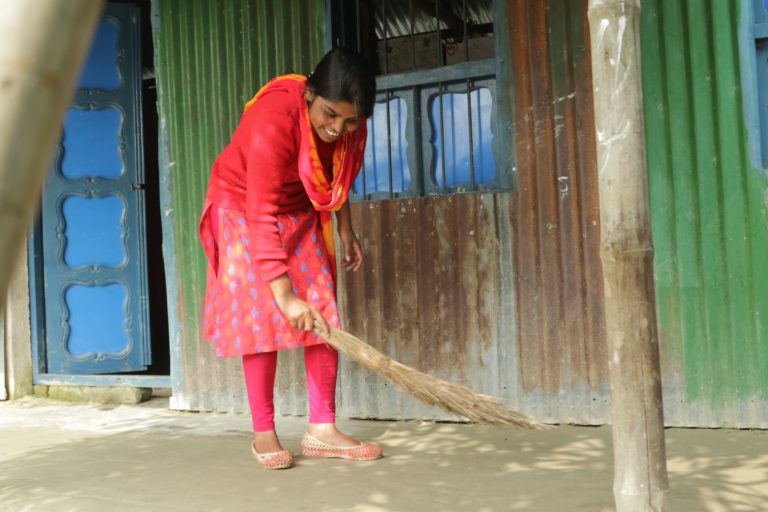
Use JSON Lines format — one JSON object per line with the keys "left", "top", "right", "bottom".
{"left": 41, "top": 4, "right": 150, "bottom": 374}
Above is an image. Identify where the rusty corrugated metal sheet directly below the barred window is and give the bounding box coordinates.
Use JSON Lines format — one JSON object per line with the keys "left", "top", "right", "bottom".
{"left": 339, "top": 194, "right": 514, "bottom": 419}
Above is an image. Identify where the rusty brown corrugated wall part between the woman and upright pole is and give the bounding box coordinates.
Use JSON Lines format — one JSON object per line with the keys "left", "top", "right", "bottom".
{"left": 340, "top": 0, "right": 607, "bottom": 423}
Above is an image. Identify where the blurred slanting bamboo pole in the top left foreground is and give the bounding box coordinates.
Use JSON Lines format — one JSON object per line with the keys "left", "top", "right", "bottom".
{"left": 0, "top": 0, "right": 103, "bottom": 311}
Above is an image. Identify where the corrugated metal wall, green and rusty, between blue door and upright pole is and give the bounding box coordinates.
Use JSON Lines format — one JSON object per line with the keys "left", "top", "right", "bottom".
{"left": 154, "top": 0, "right": 606, "bottom": 422}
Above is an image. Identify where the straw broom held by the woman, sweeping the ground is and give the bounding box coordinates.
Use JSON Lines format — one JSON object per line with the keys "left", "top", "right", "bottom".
{"left": 315, "top": 327, "right": 549, "bottom": 429}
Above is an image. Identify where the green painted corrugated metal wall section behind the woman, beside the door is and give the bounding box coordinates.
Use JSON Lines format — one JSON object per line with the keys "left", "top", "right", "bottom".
{"left": 153, "top": 0, "right": 325, "bottom": 412}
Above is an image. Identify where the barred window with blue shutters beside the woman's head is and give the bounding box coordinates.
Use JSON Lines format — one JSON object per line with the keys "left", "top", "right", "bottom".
{"left": 332, "top": 0, "right": 506, "bottom": 200}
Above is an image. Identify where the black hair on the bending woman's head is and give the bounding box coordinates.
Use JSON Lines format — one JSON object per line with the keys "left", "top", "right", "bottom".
{"left": 307, "top": 47, "right": 376, "bottom": 117}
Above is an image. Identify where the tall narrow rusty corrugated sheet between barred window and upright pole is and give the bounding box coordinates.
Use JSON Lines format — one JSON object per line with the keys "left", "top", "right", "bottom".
{"left": 508, "top": 1, "right": 607, "bottom": 402}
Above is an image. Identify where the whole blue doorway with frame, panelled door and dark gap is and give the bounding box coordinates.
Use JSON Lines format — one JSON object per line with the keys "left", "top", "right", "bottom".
{"left": 29, "top": 0, "right": 170, "bottom": 387}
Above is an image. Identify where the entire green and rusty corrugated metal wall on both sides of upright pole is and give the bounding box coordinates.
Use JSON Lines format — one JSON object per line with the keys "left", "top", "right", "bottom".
{"left": 155, "top": 0, "right": 768, "bottom": 426}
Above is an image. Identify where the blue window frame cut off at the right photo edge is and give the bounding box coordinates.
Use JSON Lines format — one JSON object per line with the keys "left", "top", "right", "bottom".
{"left": 740, "top": 0, "right": 768, "bottom": 170}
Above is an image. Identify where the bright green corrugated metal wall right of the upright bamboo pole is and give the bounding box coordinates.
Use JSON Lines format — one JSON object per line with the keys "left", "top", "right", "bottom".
{"left": 641, "top": 0, "right": 768, "bottom": 427}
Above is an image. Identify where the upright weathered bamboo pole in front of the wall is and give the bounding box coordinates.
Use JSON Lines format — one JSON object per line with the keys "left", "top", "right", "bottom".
{"left": 588, "top": 0, "right": 669, "bottom": 512}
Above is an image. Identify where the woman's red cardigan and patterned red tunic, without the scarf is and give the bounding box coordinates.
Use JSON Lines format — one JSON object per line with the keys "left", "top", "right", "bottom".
{"left": 200, "top": 84, "right": 339, "bottom": 357}
